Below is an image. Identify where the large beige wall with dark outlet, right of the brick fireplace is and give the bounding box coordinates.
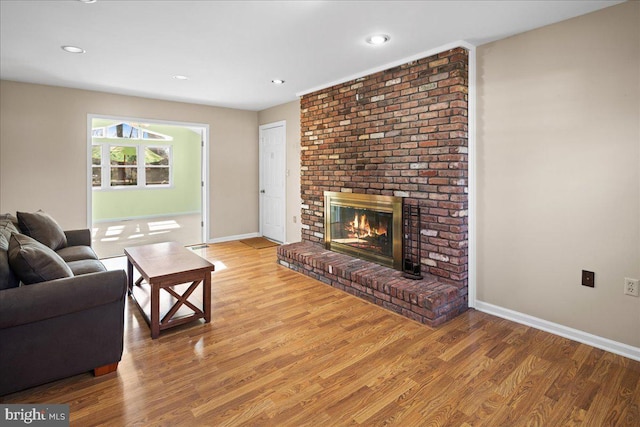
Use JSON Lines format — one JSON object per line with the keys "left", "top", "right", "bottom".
{"left": 477, "top": 2, "right": 640, "bottom": 347}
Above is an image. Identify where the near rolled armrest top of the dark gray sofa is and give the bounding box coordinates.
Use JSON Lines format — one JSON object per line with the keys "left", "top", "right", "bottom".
{"left": 0, "top": 270, "right": 127, "bottom": 328}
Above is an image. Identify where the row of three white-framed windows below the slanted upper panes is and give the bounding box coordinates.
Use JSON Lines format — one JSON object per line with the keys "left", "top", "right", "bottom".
{"left": 91, "top": 143, "right": 172, "bottom": 189}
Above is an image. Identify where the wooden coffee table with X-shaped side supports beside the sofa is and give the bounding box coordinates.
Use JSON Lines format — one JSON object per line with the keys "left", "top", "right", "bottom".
{"left": 124, "top": 242, "right": 214, "bottom": 339}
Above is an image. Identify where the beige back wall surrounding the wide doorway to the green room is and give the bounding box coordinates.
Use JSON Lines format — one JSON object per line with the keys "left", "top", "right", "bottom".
{"left": 0, "top": 81, "right": 259, "bottom": 238}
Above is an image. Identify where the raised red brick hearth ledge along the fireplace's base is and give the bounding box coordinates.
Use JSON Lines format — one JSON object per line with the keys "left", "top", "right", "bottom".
{"left": 278, "top": 242, "right": 467, "bottom": 326}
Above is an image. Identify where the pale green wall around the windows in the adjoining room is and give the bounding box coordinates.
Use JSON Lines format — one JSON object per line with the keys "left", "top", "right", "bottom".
{"left": 92, "top": 119, "right": 202, "bottom": 221}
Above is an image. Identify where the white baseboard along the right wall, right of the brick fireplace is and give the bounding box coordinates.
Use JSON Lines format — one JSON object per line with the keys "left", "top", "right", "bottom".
{"left": 475, "top": 300, "right": 640, "bottom": 362}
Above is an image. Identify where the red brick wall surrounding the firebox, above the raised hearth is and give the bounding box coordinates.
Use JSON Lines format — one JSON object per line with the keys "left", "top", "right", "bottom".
{"left": 301, "top": 48, "right": 468, "bottom": 287}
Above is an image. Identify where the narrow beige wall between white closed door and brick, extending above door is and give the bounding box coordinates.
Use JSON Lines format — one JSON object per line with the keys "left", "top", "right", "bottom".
{"left": 258, "top": 100, "right": 301, "bottom": 243}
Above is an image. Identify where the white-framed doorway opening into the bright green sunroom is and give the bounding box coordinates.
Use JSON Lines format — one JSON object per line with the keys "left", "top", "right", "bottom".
{"left": 87, "top": 116, "right": 209, "bottom": 259}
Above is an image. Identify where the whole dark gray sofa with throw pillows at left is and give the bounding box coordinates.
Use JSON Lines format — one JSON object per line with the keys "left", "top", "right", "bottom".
{"left": 0, "top": 212, "right": 127, "bottom": 395}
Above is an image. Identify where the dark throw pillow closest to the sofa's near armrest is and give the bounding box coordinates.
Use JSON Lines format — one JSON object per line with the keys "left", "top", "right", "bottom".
{"left": 9, "top": 233, "right": 73, "bottom": 285}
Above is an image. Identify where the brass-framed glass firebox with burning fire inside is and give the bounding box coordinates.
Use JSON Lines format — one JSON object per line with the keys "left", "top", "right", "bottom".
{"left": 324, "top": 191, "right": 402, "bottom": 269}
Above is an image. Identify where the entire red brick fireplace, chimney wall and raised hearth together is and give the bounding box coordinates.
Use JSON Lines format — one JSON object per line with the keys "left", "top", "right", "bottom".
{"left": 278, "top": 48, "right": 468, "bottom": 326}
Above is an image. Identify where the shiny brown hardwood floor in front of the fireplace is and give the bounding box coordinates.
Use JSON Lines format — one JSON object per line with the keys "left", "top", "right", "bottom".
{"left": 0, "top": 242, "right": 640, "bottom": 426}
